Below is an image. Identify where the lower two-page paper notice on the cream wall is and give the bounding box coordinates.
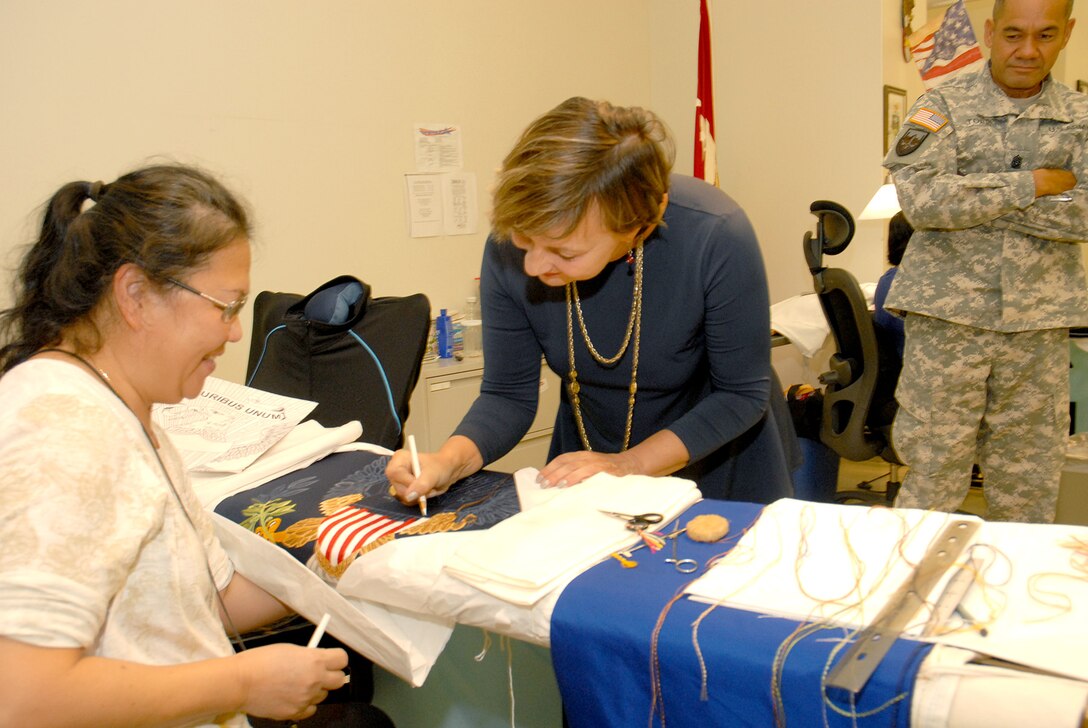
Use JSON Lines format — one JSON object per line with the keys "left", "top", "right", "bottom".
{"left": 405, "top": 172, "right": 479, "bottom": 237}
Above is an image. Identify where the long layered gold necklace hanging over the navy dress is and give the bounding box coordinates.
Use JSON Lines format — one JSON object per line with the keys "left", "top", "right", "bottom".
{"left": 567, "top": 240, "right": 643, "bottom": 453}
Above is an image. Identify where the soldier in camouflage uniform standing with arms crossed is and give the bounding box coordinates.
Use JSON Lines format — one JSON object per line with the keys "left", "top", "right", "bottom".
{"left": 885, "top": 0, "right": 1088, "bottom": 522}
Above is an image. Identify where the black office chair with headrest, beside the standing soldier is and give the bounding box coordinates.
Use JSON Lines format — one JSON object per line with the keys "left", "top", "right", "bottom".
{"left": 804, "top": 200, "right": 902, "bottom": 505}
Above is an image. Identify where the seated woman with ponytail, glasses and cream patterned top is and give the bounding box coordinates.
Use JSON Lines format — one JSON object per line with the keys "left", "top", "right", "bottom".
{"left": 0, "top": 165, "right": 347, "bottom": 726}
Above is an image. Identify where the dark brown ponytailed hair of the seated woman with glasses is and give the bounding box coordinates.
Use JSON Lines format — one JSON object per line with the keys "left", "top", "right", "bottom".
{"left": 0, "top": 165, "right": 249, "bottom": 371}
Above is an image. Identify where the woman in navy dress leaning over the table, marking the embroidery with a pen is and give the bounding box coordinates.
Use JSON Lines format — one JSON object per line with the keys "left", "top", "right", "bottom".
{"left": 387, "top": 98, "right": 790, "bottom": 503}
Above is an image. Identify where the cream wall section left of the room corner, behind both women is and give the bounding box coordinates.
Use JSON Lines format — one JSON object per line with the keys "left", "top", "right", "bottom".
{"left": 0, "top": 0, "right": 650, "bottom": 379}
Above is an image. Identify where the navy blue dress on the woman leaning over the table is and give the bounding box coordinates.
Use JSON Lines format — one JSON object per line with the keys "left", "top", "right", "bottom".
{"left": 455, "top": 175, "right": 792, "bottom": 503}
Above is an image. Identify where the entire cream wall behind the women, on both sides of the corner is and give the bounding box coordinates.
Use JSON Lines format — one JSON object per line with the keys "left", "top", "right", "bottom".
{"left": 0, "top": 0, "right": 882, "bottom": 381}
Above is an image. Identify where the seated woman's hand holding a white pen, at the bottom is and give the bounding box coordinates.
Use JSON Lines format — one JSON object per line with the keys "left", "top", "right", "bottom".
{"left": 234, "top": 644, "right": 347, "bottom": 720}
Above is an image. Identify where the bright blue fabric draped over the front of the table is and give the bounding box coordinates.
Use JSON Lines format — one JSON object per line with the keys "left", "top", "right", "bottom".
{"left": 551, "top": 501, "right": 931, "bottom": 728}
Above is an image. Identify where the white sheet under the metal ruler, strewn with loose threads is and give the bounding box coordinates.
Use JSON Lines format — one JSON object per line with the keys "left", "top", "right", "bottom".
{"left": 687, "top": 498, "right": 1088, "bottom": 680}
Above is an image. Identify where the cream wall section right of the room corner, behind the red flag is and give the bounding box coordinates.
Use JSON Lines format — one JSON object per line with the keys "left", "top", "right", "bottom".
{"left": 647, "top": 0, "right": 885, "bottom": 385}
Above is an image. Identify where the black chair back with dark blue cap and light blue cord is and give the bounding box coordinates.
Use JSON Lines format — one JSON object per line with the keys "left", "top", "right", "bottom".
{"left": 246, "top": 275, "right": 431, "bottom": 449}
